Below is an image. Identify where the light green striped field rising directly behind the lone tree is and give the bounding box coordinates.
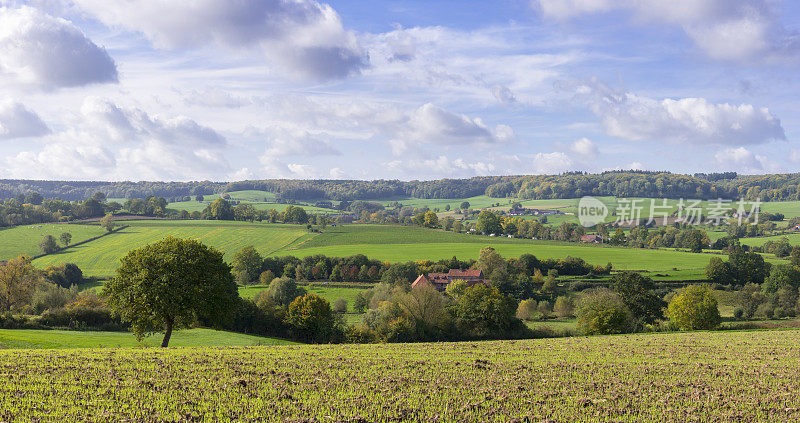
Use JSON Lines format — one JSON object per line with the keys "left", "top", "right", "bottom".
{"left": 34, "top": 221, "right": 307, "bottom": 276}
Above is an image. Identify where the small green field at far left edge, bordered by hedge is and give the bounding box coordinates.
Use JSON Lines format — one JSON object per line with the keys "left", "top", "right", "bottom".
{"left": 0, "top": 223, "right": 105, "bottom": 260}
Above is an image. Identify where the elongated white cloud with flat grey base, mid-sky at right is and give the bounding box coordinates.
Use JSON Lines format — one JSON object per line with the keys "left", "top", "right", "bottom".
{"left": 576, "top": 81, "right": 786, "bottom": 145}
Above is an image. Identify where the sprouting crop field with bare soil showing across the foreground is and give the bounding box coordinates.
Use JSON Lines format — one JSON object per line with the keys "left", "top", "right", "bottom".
{"left": 0, "top": 330, "right": 800, "bottom": 422}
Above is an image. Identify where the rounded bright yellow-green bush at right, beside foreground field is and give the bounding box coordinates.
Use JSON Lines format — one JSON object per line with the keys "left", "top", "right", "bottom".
{"left": 667, "top": 285, "right": 722, "bottom": 330}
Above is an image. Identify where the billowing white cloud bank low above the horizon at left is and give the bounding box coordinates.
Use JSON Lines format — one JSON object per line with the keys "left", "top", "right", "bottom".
{"left": 5, "top": 98, "right": 229, "bottom": 180}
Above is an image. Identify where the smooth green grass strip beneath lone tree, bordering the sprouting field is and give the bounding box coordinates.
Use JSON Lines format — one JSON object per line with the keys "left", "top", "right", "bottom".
{"left": 0, "top": 329, "right": 293, "bottom": 350}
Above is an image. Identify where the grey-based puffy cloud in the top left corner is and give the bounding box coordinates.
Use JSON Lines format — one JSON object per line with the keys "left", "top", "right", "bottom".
{"left": 0, "top": 7, "right": 117, "bottom": 89}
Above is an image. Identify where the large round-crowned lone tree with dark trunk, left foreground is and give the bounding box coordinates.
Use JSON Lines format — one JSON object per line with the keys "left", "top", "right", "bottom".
{"left": 103, "top": 236, "right": 239, "bottom": 347}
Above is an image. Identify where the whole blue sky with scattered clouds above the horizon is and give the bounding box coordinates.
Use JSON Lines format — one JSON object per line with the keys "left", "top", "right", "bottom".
{"left": 0, "top": 0, "right": 800, "bottom": 181}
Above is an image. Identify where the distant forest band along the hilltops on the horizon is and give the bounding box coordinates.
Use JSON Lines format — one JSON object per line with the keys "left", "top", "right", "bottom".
{"left": 0, "top": 171, "right": 800, "bottom": 205}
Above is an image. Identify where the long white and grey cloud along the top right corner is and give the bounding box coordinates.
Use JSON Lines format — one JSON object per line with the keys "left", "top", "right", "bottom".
{"left": 533, "top": 0, "right": 800, "bottom": 61}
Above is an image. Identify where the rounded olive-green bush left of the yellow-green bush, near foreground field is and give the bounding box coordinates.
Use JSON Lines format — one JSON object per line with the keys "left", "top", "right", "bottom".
{"left": 577, "top": 288, "right": 634, "bottom": 335}
